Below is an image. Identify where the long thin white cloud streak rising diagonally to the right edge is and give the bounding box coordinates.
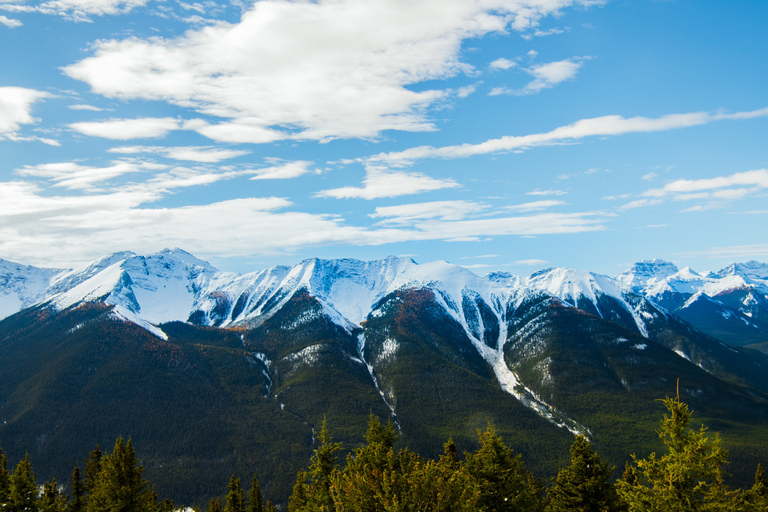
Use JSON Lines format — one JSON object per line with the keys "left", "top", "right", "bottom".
{"left": 367, "top": 108, "right": 768, "bottom": 165}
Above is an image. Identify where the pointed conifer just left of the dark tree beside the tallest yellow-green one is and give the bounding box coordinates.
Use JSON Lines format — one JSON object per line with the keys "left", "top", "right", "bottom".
{"left": 465, "top": 425, "right": 544, "bottom": 512}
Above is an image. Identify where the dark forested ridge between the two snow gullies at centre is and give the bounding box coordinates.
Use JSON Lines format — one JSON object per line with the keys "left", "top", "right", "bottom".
{"left": 365, "top": 290, "right": 572, "bottom": 475}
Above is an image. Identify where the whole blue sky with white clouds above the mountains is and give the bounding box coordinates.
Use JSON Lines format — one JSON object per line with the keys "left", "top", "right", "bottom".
{"left": 0, "top": 0, "right": 768, "bottom": 276}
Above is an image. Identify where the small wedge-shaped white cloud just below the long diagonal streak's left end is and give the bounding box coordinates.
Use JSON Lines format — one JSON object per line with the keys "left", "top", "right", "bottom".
{"left": 317, "top": 166, "right": 459, "bottom": 199}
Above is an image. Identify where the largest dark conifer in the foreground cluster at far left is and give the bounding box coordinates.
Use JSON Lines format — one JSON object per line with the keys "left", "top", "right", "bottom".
{"left": 86, "top": 437, "right": 157, "bottom": 512}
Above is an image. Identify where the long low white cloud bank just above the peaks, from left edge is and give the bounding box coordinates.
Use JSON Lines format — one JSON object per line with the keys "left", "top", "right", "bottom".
{"left": 0, "top": 177, "right": 605, "bottom": 264}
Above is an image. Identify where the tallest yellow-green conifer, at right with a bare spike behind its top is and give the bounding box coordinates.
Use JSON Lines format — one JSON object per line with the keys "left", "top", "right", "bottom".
{"left": 616, "top": 397, "right": 737, "bottom": 512}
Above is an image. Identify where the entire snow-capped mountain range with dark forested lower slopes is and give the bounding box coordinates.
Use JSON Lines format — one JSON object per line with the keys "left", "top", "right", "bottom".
{"left": 0, "top": 249, "right": 768, "bottom": 502}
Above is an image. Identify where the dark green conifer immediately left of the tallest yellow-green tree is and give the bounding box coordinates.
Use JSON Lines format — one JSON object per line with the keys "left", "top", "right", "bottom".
{"left": 547, "top": 435, "right": 621, "bottom": 512}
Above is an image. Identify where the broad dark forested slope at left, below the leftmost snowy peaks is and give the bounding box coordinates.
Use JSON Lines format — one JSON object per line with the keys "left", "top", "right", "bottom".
{"left": 0, "top": 304, "right": 312, "bottom": 504}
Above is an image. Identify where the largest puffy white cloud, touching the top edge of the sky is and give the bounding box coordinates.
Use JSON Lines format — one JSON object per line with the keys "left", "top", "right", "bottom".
{"left": 64, "top": 0, "right": 590, "bottom": 143}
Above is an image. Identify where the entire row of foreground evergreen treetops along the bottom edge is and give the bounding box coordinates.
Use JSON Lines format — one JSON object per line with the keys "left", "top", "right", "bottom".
{"left": 0, "top": 397, "right": 768, "bottom": 512}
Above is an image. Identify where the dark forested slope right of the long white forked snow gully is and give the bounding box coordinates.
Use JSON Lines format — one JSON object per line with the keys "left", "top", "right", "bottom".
{"left": 505, "top": 299, "right": 768, "bottom": 479}
